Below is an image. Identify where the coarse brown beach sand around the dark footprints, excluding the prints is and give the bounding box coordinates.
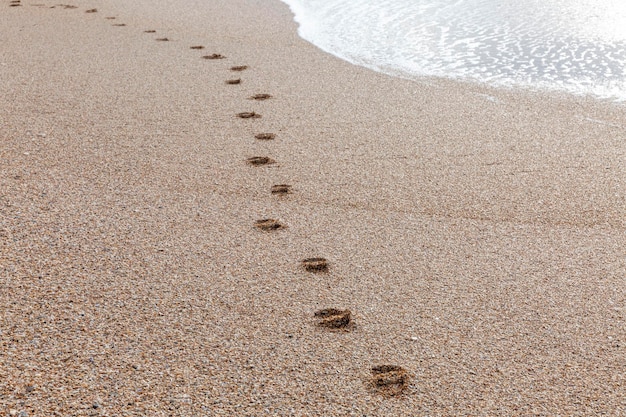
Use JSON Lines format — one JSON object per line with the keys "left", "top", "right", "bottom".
{"left": 0, "top": 0, "right": 626, "bottom": 417}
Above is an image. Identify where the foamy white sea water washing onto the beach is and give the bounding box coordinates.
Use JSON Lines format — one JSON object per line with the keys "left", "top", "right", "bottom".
{"left": 283, "top": 0, "right": 626, "bottom": 102}
